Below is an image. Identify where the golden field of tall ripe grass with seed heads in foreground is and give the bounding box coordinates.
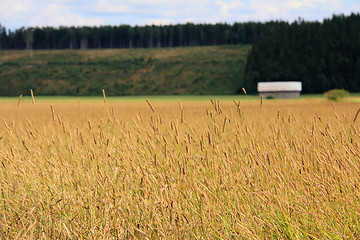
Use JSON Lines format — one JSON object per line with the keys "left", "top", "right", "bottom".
{"left": 0, "top": 98, "right": 360, "bottom": 239}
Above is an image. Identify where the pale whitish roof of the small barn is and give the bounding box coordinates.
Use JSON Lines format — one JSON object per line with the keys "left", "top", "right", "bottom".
{"left": 257, "top": 82, "right": 302, "bottom": 92}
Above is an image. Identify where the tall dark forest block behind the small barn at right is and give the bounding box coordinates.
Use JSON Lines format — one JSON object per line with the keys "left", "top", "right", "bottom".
{"left": 245, "top": 13, "right": 360, "bottom": 93}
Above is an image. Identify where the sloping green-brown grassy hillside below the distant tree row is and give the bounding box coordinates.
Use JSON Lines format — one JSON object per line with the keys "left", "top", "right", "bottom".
{"left": 0, "top": 45, "right": 251, "bottom": 96}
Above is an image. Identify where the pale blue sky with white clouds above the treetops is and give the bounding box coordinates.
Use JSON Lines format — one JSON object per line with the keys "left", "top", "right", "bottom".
{"left": 0, "top": 0, "right": 360, "bottom": 30}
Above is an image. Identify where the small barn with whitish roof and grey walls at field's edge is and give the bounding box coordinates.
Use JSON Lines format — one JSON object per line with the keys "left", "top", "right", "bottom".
{"left": 257, "top": 82, "right": 302, "bottom": 98}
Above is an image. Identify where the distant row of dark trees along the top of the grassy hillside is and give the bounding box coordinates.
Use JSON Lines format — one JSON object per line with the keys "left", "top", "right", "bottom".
{"left": 0, "top": 22, "right": 265, "bottom": 49}
